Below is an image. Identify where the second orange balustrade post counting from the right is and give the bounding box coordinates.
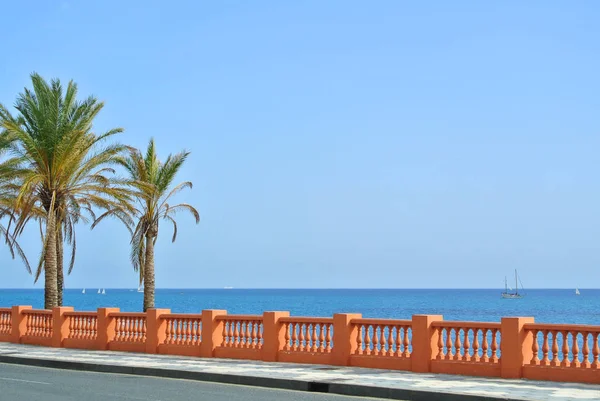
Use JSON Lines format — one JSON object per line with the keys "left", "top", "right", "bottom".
{"left": 410, "top": 315, "right": 444, "bottom": 373}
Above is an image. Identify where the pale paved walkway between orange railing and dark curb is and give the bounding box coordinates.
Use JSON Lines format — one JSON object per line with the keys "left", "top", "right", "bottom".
{"left": 0, "top": 343, "right": 600, "bottom": 401}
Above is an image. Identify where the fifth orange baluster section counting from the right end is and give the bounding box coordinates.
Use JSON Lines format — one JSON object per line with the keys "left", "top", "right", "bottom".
{"left": 215, "top": 315, "right": 263, "bottom": 359}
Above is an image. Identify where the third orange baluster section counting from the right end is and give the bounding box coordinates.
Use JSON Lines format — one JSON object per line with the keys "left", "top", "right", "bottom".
{"left": 350, "top": 319, "right": 412, "bottom": 370}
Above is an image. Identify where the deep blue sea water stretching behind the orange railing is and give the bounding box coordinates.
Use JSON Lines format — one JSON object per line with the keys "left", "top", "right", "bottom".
{"left": 0, "top": 289, "right": 600, "bottom": 325}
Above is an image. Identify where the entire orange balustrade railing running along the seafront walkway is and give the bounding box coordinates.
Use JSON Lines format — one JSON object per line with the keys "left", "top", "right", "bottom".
{"left": 0, "top": 306, "right": 600, "bottom": 384}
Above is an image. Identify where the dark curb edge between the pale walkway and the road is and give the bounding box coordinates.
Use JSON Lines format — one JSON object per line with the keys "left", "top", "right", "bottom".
{"left": 0, "top": 354, "right": 522, "bottom": 401}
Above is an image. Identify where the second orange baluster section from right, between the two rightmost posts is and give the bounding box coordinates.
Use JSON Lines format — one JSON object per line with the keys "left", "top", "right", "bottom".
{"left": 431, "top": 321, "right": 501, "bottom": 376}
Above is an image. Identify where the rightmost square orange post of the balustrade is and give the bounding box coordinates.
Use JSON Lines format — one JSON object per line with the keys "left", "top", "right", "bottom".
{"left": 500, "top": 317, "right": 535, "bottom": 379}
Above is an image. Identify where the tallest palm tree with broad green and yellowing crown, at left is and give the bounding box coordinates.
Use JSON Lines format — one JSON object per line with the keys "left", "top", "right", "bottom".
{"left": 0, "top": 73, "right": 131, "bottom": 308}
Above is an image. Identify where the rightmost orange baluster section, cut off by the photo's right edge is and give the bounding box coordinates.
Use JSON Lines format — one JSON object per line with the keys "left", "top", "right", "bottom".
{"left": 523, "top": 323, "right": 600, "bottom": 383}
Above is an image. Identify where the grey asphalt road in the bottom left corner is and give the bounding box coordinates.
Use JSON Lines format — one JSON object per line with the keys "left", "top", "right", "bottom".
{"left": 0, "top": 363, "right": 394, "bottom": 401}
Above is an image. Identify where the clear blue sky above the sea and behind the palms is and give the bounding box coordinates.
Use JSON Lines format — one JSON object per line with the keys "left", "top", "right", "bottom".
{"left": 0, "top": 0, "right": 600, "bottom": 288}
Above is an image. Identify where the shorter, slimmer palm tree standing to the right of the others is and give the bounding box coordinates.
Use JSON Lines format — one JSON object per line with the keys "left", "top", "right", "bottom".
{"left": 98, "top": 139, "right": 200, "bottom": 312}
